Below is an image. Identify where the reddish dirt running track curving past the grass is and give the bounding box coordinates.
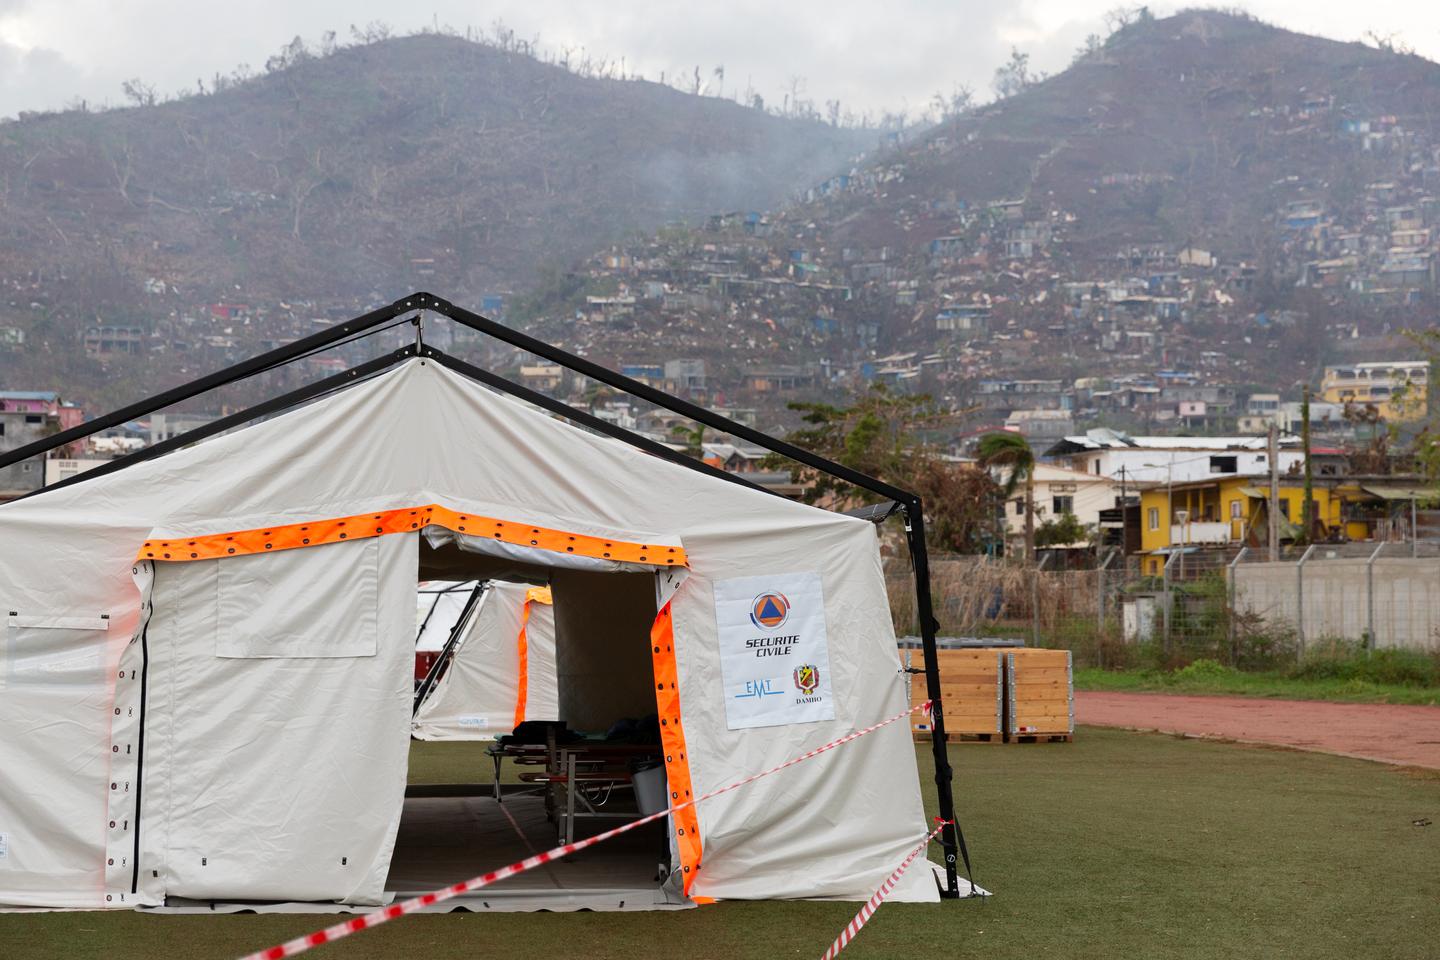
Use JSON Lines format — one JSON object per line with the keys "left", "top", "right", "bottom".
{"left": 1076, "top": 691, "right": 1440, "bottom": 770}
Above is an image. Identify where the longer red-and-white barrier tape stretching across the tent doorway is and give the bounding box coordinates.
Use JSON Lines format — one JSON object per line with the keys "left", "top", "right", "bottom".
{"left": 240, "top": 701, "right": 930, "bottom": 960}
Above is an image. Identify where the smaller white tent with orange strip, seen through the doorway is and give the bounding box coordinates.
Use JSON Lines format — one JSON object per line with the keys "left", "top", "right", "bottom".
{"left": 412, "top": 580, "right": 560, "bottom": 740}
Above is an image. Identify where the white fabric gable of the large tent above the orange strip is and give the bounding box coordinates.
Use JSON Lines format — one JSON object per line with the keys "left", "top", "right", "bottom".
{"left": 0, "top": 360, "right": 863, "bottom": 556}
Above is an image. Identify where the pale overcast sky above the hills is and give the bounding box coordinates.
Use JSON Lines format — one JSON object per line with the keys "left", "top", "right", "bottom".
{"left": 0, "top": 0, "right": 1440, "bottom": 115}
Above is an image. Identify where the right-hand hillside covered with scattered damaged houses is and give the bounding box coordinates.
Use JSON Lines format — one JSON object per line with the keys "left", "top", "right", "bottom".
{"left": 512, "top": 12, "right": 1440, "bottom": 430}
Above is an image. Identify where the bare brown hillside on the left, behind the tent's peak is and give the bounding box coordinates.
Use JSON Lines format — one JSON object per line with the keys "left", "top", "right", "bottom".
{"left": 0, "top": 35, "right": 874, "bottom": 405}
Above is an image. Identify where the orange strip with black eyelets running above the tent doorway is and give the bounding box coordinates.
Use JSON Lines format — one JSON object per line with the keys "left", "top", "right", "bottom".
{"left": 140, "top": 504, "right": 687, "bottom": 567}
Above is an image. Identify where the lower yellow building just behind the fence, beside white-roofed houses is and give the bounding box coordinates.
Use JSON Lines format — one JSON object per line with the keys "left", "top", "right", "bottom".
{"left": 1140, "top": 476, "right": 1375, "bottom": 576}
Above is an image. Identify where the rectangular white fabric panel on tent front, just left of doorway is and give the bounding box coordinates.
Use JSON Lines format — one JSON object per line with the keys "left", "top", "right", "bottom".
{"left": 215, "top": 537, "right": 380, "bottom": 659}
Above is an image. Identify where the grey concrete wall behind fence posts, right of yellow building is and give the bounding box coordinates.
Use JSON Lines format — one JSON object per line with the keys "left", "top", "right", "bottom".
{"left": 1231, "top": 557, "right": 1440, "bottom": 649}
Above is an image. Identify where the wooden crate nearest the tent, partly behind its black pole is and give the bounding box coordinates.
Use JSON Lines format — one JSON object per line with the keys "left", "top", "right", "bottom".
{"left": 901, "top": 649, "right": 1005, "bottom": 743}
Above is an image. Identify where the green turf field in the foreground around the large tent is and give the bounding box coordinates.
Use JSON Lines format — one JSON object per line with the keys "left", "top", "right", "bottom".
{"left": 11, "top": 728, "right": 1440, "bottom": 960}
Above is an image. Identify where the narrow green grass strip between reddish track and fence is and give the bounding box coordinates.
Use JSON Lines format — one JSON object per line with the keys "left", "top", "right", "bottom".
{"left": 1076, "top": 668, "right": 1440, "bottom": 705}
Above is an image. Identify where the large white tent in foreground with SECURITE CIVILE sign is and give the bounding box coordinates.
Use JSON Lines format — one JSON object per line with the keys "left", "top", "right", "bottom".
{"left": 0, "top": 358, "right": 937, "bottom": 908}
